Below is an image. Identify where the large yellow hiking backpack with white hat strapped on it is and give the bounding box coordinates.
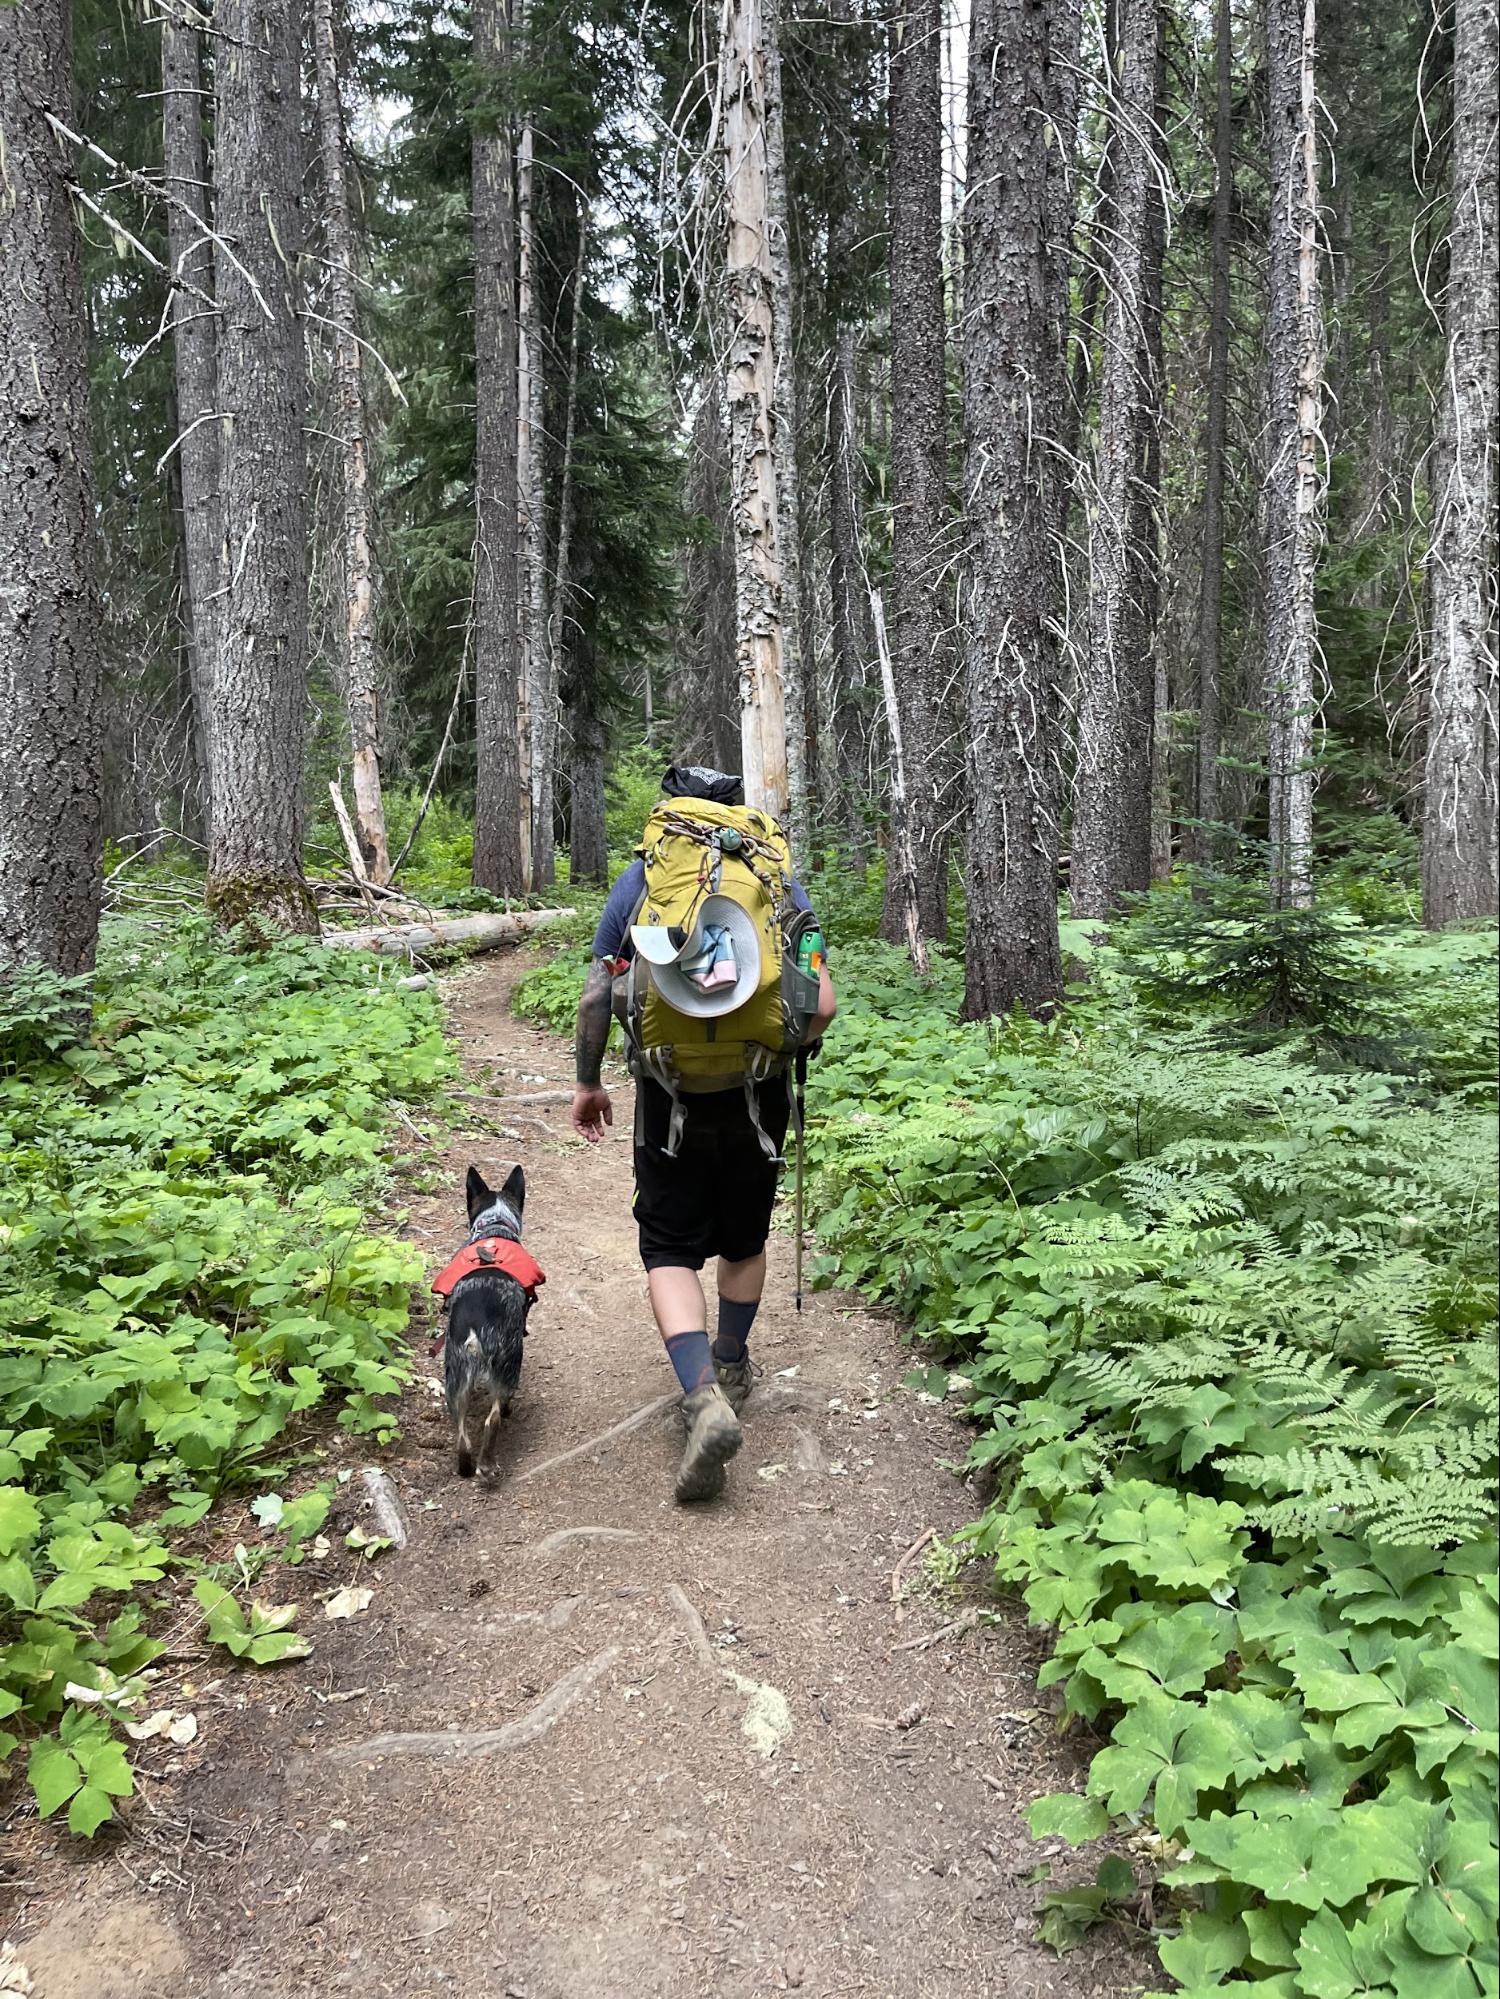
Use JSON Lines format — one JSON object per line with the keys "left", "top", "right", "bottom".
{"left": 614, "top": 798, "right": 818, "bottom": 1157}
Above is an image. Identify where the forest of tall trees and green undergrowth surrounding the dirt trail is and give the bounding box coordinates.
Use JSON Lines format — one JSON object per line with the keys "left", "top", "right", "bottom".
{"left": 0, "top": 0, "right": 1500, "bottom": 1999}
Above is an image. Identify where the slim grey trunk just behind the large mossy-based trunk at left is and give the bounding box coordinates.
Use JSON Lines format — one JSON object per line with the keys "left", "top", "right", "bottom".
{"left": 160, "top": 12, "right": 226, "bottom": 830}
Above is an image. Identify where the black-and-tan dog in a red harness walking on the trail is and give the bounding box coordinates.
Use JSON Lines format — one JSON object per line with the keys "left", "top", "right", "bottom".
{"left": 432, "top": 1165, "right": 546, "bottom": 1479}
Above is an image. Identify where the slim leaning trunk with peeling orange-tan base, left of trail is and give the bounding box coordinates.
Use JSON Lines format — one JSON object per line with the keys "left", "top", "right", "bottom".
{"left": 312, "top": 0, "right": 390, "bottom": 882}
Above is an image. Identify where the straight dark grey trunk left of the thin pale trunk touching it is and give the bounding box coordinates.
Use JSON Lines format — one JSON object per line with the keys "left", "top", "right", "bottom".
{"left": 472, "top": 0, "right": 528, "bottom": 896}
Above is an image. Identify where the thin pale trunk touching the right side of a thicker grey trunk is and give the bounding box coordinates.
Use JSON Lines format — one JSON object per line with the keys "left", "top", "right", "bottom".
{"left": 516, "top": 31, "right": 552, "bottom": 886}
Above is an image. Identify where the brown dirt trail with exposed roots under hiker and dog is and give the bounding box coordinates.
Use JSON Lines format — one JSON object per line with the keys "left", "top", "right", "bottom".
{"left": 0, "top": 956, "right": 1146, "bottom": 1999}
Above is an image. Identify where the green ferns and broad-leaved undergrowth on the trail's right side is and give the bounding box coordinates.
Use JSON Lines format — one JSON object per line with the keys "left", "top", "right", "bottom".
{"left": 518, "top": 868, "right": 1500, "bottom": 1999}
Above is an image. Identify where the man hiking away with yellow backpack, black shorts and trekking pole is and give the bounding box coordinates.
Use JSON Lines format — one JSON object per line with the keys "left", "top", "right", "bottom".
{"left": 572, "top": 766, "right": 836, "bottom": 1501}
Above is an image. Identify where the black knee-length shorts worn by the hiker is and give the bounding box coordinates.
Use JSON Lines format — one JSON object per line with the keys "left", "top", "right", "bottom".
{"left": 636, "top": 1075, "right": 790, "bottom": 1269}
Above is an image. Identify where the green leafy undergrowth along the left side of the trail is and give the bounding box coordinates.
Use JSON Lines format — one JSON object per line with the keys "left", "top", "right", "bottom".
{"left": 0, "top": 918, "right": 450, "bottom": 1831}
